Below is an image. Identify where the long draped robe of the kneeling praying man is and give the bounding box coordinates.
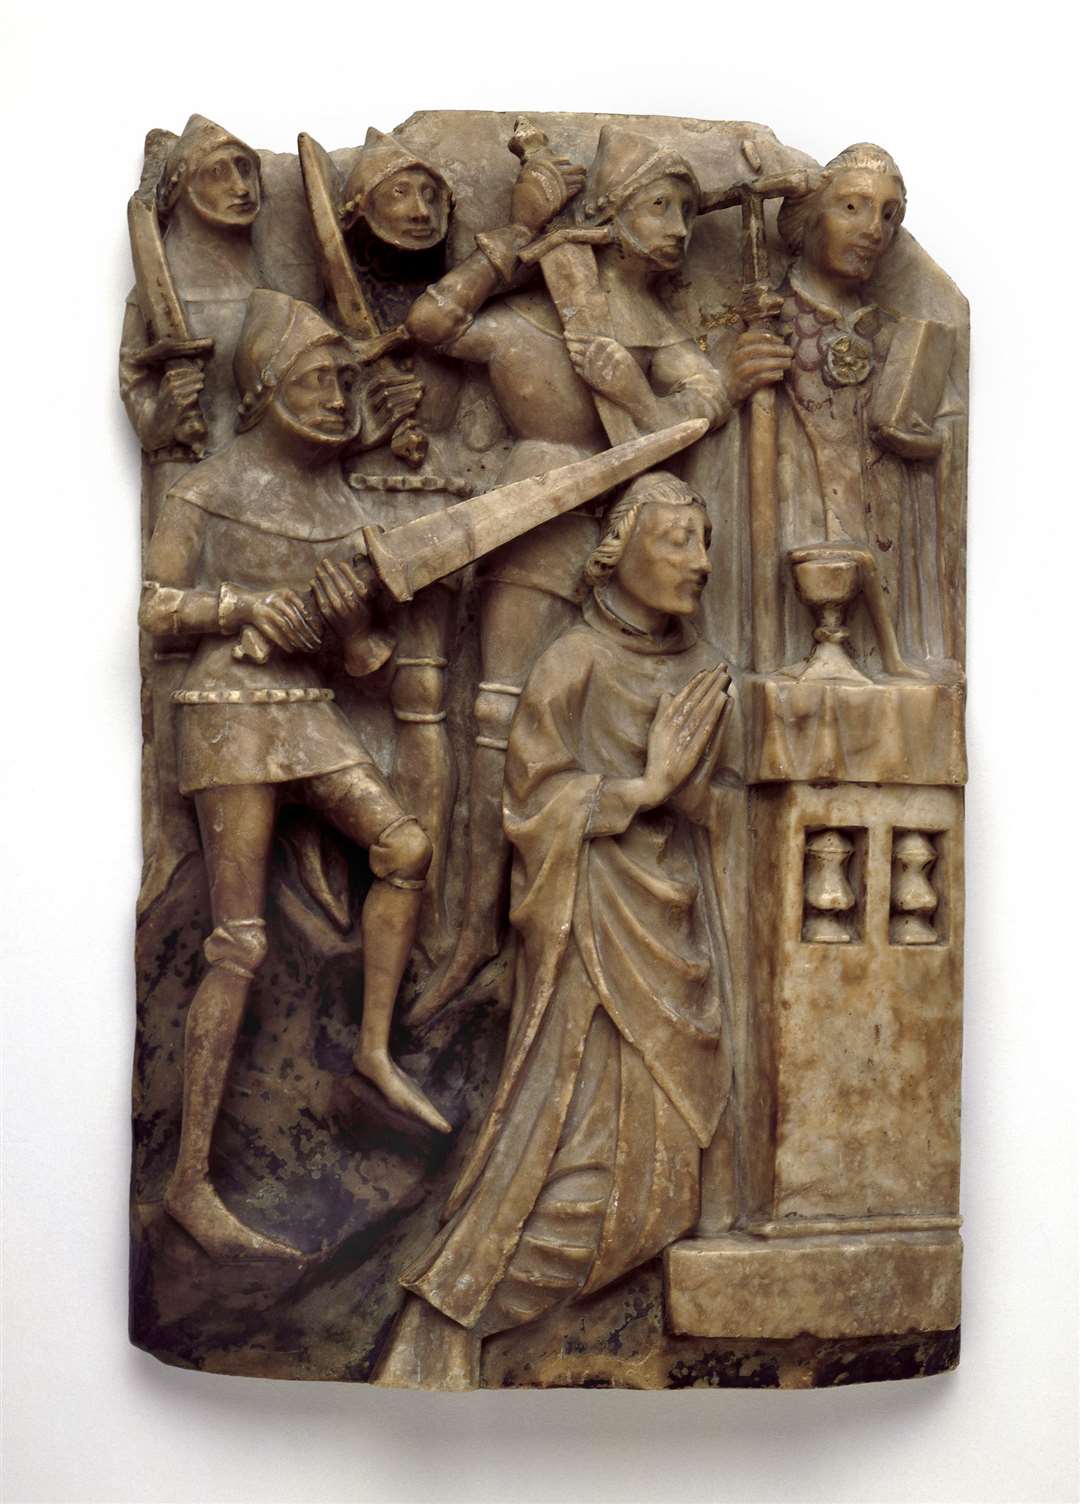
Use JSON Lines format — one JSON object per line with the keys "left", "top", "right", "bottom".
{"left": 402, "top": 599, "right": 731, "bottom": 1334}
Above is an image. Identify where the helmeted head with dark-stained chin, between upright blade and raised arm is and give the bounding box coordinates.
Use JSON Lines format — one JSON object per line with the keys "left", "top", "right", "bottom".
{"left": 340, "top": 126, "right": 454, "bottom": 251}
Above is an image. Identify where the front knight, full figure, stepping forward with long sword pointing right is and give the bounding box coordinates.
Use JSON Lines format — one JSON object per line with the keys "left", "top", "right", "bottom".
{"left": 140, "top": 282, "right": 704, "bottom": 1259}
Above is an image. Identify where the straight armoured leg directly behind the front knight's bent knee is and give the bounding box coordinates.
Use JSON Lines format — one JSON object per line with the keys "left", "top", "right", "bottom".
{"left": 391, "top": 585, "right": 457, "bottom": 952}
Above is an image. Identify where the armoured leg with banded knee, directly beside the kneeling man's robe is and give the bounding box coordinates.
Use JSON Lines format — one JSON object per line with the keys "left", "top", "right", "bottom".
{"left": 409, "top": 584, "right": 578, "bottom": 1023}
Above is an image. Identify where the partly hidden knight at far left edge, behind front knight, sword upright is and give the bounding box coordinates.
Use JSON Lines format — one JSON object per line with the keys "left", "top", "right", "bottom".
{"left": 120, "top": 114, "right": 266, "bottom": 916}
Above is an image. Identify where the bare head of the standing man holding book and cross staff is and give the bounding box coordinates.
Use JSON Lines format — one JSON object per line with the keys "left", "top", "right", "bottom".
{"left": 776, "top": 141, "right": 907, "bottom": 284}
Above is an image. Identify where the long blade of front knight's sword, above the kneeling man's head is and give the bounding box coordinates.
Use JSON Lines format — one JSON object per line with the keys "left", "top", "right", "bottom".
{"left": 364, "top": 418, "right": 708, "bottom": 602}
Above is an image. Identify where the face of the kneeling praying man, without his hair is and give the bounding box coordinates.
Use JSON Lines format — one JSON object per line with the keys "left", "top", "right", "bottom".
{"left": 615, "top": 501, "right": 711, "bottom": 617}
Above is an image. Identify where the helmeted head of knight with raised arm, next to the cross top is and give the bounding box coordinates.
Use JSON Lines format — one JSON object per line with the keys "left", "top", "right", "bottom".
{"left": 578, "top": 125, "right": 701, "bottom": 271}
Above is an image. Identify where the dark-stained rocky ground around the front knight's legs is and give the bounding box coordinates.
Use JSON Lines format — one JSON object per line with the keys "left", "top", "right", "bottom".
{"left": 131, "top": 850, "right": 505, "bottom": 1382}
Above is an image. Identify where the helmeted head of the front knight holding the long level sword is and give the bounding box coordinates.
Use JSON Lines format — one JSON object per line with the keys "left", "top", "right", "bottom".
{"left": 233, "top": 287, "right": 361, "bottom": 450}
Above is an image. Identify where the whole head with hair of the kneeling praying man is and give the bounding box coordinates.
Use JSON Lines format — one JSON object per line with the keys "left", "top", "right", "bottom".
{"left": 585, "top": 471, "right": 713, "bottom": 617}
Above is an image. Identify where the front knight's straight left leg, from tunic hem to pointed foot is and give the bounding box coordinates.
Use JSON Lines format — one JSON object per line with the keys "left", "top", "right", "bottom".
{"left": 165, "top": 788, "right": 301, "bottom": 1259}
